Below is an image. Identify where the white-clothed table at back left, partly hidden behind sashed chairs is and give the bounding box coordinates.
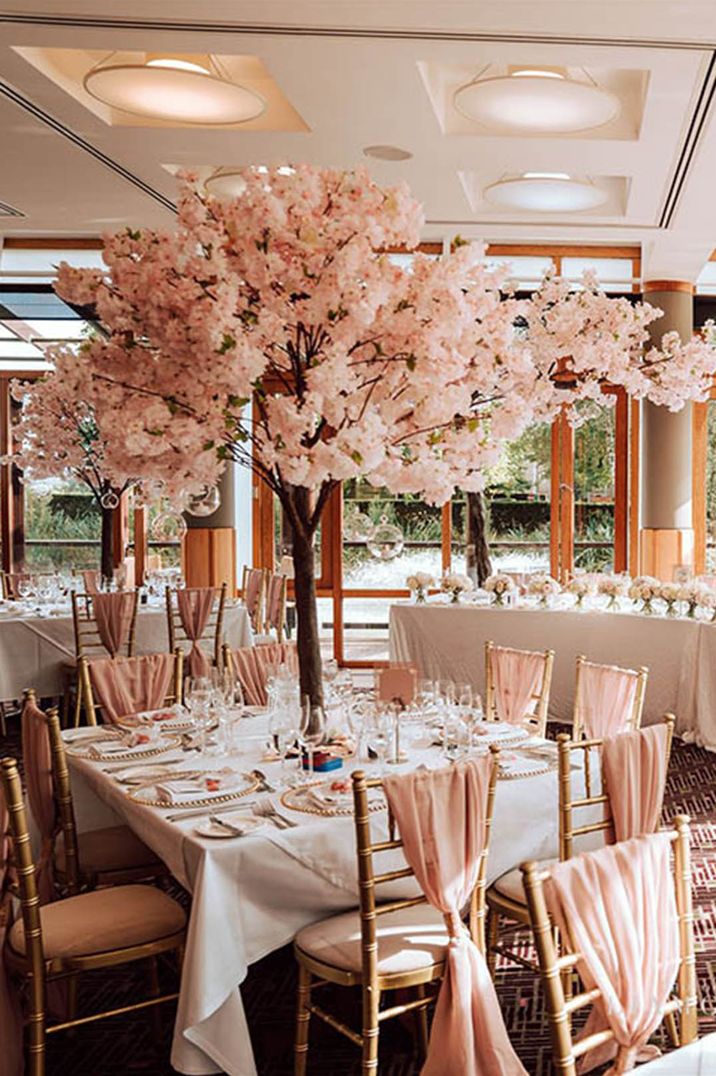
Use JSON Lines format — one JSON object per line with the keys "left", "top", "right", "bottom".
{"left": 0, "top": 604, "right": 252, "bottom": 699}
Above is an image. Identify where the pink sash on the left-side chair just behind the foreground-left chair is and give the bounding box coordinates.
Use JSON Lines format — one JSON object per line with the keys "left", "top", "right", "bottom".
{"left": 22, "top": 698, "right": 57, "bottom": 904}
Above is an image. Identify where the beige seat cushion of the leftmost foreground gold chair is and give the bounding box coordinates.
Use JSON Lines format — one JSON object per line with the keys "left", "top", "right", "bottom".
{"left": 8, "top": 886, "right": 186, "bottom": 960}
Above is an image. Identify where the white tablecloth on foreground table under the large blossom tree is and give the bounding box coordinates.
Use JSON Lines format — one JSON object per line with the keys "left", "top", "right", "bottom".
{"left": 65, "top": 713, "right": 581, "bottom": 1076}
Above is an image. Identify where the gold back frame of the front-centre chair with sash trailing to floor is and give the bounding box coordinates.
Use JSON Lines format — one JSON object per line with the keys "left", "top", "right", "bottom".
{"left": 352, "top": 746, "right": 500, "bottom": 986}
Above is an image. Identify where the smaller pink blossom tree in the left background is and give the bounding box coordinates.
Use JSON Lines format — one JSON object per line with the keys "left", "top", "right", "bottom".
{"left": 5, "top": 343, "right": 131, "bottom": 579}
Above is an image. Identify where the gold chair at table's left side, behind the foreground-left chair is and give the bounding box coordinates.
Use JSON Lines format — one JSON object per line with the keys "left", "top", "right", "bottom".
{"left": 45, "top": 708, "right": 167, "bottom": 896}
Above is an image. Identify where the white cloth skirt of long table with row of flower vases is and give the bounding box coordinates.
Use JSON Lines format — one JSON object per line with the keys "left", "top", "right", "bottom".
{"left": 390, "top": 603, "right": 716, "bottom": 750}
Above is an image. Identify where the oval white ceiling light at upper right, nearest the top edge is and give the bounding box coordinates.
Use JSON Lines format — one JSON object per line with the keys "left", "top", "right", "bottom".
{"left": 453, "top": 68, "right": 621, "bottom": 135}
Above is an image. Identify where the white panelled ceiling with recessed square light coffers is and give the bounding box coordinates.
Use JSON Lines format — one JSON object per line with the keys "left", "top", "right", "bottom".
{"left": 0, "top": 0, "right": 716, "bottom": 280}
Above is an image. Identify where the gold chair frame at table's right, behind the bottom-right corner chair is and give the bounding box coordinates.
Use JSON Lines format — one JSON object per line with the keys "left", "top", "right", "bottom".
{"left": 486, "top": 713, "right": 676, "bottom": 972}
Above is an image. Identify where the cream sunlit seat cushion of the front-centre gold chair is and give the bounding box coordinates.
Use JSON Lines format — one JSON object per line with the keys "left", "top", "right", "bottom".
{"left": 295, "top": 904, "right": 449, "bottom": 975}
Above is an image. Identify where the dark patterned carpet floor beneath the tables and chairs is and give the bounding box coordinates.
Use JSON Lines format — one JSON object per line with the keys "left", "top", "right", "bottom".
{"left": 2, "top": 734, "right": 716, "bottom": 1076}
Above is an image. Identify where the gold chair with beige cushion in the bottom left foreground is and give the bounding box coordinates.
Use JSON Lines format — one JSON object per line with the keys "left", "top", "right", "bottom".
{"left": 0, "top": 759, "right": 186, "bottom": 1076}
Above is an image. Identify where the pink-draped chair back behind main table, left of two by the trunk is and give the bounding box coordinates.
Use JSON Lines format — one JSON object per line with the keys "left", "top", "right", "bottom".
{"left": 80, "top": 647, "right": 184, "bottom": 725}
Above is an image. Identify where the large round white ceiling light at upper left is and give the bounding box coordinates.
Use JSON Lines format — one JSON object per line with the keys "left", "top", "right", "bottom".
{"left": 83, "top": 53, "right": 266, "bottom": 126}
